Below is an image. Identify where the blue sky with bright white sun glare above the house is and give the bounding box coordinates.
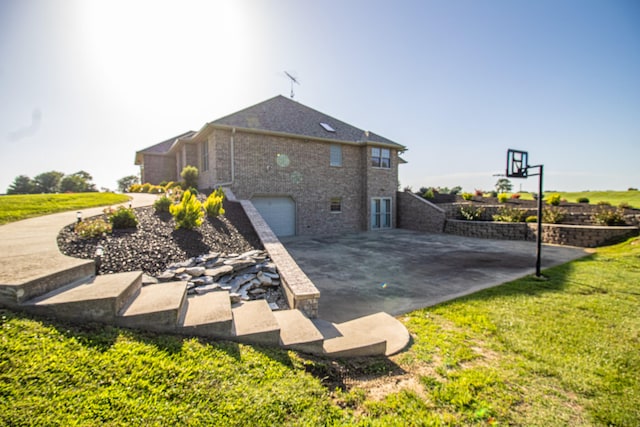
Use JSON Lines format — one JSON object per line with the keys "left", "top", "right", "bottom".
{"left": 0, "top": 0, "right": 640, "bottom": 193}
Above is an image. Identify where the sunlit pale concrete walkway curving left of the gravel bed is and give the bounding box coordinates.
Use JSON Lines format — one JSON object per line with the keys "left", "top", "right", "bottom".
{"left": 0, "top": 194, "right": 157, "bottom": 298}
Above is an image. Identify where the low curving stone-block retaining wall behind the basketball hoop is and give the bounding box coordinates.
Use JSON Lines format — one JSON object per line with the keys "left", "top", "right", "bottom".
{"left": 444, "top": 219, "right": 640, "bottom": 248}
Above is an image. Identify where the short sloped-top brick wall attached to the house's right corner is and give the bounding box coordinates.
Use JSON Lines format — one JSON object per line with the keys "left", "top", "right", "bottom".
{"left": 396, "top": 191, "right": 446, "bottom": 233}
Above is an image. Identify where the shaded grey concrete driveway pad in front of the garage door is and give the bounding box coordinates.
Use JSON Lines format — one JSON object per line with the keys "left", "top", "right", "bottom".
{"left": 282, "top": 229, "right": 587, "bottom": 323}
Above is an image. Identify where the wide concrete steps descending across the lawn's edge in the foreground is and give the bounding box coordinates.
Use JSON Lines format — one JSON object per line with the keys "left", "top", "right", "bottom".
{"left": 13, "top": 272, "right": 410, "bottom": 358}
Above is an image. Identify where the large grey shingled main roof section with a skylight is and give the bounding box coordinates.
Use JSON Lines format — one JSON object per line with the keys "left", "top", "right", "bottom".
{"left": 208, "top": 95, "right": 405, "bottom": 150}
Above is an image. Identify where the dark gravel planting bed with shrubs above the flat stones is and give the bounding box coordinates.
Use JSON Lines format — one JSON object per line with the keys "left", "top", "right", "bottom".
{"left": 58, "top": 202, "right": 263, "bottom": 276}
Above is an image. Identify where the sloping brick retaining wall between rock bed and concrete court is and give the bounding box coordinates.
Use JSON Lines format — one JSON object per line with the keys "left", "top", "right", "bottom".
{"left": 224, "top": 188, "right": 320, "bottom": 319}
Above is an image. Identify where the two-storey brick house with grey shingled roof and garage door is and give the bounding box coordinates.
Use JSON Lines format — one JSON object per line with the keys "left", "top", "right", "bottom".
{"left": 136, "top": 96, "right": 406, "bottom": 236}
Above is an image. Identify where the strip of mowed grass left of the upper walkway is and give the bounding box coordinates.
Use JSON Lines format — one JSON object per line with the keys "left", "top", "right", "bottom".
{"left": 0, "top": 193, "right": 129, "bottom": 224}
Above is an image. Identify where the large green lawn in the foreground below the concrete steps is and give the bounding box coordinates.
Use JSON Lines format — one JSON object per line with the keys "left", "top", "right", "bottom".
{"left": 0, "top": 238, "right": 640, "bottom": 426}
